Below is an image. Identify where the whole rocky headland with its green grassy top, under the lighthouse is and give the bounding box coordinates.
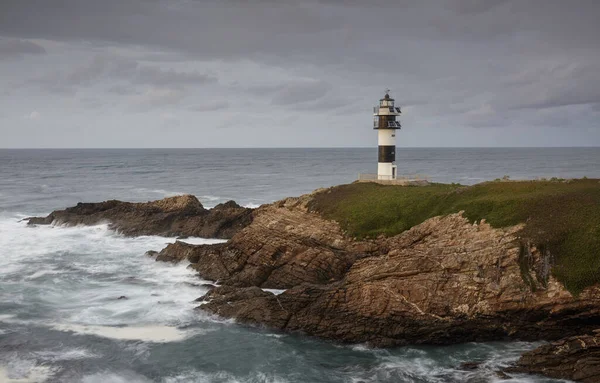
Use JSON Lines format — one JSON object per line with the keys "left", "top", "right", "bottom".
{"left": 30, "top": 180, "right": 600, "bottom": 382}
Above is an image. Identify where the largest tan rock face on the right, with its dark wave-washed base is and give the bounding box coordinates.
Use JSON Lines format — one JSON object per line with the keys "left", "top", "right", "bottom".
{"left": 199, "top": 214, "right": 600, "bottom": 346}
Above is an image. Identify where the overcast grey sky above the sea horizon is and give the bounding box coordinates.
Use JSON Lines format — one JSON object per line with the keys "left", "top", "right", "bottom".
{"left": 0, "top": 0, "right": 600, "bottom": 148}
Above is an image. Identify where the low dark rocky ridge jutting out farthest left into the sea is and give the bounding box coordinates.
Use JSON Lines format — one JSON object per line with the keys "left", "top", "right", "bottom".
{"left": 29, "top": 195, "right": 252, "bottom": 238}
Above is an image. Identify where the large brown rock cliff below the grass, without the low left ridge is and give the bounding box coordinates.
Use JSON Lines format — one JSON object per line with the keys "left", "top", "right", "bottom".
{"left": 195, "top": 213, "right": 600, "bottom": 346}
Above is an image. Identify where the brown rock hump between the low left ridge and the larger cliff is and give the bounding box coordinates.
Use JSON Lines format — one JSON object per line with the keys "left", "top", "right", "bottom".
{"left": 157, "top": 198, "right": 377, "bottom": 289}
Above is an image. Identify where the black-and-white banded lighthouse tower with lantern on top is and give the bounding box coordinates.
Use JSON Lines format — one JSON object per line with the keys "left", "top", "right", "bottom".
{"left": 373, "top": 90, "right": 400, "bottom": 180}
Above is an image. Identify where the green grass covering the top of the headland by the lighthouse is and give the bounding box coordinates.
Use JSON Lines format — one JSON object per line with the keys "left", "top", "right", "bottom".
{"left": 309, "top": 179, "right": 600, "bottom": 294}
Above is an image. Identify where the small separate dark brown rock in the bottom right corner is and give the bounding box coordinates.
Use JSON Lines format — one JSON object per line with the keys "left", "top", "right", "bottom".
{"left": 506, "top": 330, "right": 600, "bottom": 383}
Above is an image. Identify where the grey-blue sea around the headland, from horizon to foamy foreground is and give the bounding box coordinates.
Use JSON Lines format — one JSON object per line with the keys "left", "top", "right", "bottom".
{"left": 0, "top": 148, "right": 600, "bottom": 383}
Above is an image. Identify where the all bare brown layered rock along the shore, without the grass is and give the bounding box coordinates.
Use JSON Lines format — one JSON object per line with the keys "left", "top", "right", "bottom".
{"left": 29, "top": 190, "right": 600, "bottom": 382}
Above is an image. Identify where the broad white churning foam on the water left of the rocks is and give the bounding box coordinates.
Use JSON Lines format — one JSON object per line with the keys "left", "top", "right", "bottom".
{"left": 0, "top": 215, "right": 229, "bottom": 342}
